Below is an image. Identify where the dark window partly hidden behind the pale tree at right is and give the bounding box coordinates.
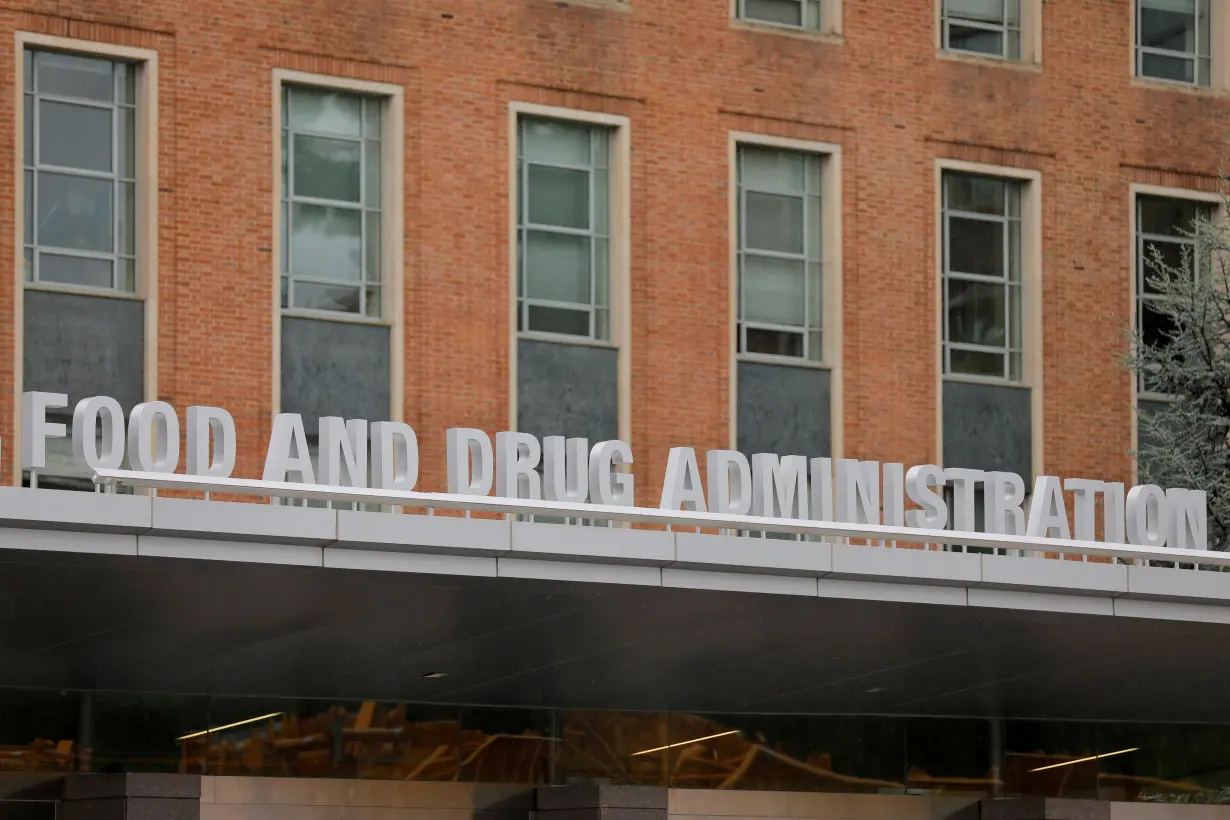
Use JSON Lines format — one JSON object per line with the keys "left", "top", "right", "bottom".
{"left": 1135, "top": 195, "right": 1213, "bottom": 393}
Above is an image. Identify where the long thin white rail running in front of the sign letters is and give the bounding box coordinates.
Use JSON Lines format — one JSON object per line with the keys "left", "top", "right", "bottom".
{"left": 86, "top": 470, "right": 1230, "bottom": 569}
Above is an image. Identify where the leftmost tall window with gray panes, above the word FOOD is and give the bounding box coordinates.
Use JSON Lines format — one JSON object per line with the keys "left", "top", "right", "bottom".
{"left": 22, "top": 49, "right": 138, "bottom": 293}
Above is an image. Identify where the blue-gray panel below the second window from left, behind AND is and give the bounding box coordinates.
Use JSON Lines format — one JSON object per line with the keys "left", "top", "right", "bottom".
{"left": 282, "top": 316, "right": 391, "bottom": 433}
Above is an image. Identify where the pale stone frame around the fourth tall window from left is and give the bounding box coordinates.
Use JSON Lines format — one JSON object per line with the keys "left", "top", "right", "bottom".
{"left": 727, "top": 130, "right": 845, "bottom": 459}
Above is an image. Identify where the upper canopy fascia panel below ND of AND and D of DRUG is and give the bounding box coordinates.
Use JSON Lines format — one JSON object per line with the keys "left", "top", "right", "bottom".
{"left": 337, "top": 510, "right": 512, "bottom": 556}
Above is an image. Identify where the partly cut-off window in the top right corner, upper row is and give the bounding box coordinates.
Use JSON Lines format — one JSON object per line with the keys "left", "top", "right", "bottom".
{"left": 1137, "top": 0, "right": 1212, "bottom": 86}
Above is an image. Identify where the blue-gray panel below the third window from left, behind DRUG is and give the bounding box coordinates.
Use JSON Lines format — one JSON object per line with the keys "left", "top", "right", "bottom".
{"left": 517, "top": 339, "right": 619, "bottom": 446}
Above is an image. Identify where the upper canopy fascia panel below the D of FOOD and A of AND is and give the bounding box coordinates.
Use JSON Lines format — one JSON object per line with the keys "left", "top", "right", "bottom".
{"left": 151, "top": 498, "right": 337, "bottom": 547}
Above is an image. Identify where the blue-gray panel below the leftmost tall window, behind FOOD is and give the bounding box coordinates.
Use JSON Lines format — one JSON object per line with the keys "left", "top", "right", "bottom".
{"left": 22, "top": 290, "right": 145, "bottom": 411}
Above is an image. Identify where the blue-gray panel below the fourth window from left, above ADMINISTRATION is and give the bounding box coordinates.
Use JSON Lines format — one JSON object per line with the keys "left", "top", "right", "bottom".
{"left": 737, "top": 361, "right": 833, "bottom": 459}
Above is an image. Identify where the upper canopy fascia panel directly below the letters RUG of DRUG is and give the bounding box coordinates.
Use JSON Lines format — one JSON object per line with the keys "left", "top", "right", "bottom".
{"left": 512, "top": 521, "right": 675, "bottom": 567}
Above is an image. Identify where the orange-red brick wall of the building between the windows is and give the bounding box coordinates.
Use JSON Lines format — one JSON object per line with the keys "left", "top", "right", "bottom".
{"left": 0, "top": 0, "right": 1230, "bottom": 504}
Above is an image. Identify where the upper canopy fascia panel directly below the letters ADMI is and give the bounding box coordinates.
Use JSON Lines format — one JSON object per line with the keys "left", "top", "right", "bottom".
{"left": 673, "top": 532, "right": 833, "bottom": 578}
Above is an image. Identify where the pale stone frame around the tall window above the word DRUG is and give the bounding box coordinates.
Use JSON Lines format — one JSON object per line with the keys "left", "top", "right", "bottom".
{"left": 507, "top": 101, "right": 632, "bottom": 441}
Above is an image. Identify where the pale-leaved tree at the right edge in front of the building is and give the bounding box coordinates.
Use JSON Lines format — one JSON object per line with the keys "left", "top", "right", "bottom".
{"left": 1128, "top": 184, "right": 1230, "bottom": 550}
